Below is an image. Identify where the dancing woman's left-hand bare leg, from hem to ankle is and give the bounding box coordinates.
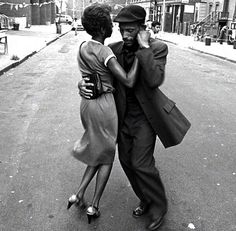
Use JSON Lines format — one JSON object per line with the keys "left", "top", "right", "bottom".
{"left": 77, "top": 166, "right": 99, "bottom": 199}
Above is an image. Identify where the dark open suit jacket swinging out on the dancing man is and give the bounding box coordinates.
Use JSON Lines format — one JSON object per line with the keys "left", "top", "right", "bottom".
{"left": 109, "top": 40, "right": 190, "bottom": 148}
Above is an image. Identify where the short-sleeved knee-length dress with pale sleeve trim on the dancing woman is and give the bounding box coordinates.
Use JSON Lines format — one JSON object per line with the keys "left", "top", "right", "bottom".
{"left": 72, "top": 40, "right": 118, "bottom": 166}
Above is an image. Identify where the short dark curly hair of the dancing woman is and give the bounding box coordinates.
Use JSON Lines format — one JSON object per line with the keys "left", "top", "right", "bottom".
{"left": 82, "top": 3, "right": 111, "bottom": 36}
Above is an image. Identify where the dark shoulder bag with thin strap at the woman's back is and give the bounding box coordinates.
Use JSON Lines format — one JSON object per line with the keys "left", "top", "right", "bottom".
{"left": 79, "top": 43, "right": 103, "bottom": 99}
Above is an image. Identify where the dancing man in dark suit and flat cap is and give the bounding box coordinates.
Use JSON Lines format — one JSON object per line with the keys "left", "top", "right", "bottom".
{"left": 79, "top": 5, "right": 188, "bottom": 230}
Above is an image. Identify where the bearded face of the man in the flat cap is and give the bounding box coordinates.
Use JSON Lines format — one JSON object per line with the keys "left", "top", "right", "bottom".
{"left": 119, "top": 22, "right": 140, "bottom": 47}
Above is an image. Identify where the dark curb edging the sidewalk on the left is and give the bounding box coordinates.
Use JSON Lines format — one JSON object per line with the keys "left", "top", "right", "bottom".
{"left": 0, "top": 30, "right": 70, "bottom": 76}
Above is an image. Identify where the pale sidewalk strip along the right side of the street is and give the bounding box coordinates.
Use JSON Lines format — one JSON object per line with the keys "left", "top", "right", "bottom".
{"left": 158, "top": 32, "right": 236, "bottom": 63}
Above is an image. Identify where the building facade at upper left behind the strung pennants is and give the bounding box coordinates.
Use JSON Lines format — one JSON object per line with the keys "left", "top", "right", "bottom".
{"left": 0, "top": 0, "right": 56, "bottom": 27}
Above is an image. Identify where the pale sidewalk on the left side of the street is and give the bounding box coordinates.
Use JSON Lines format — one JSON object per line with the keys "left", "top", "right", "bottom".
{"left": 0, "top": 24, "right": 71, "bottom": 75}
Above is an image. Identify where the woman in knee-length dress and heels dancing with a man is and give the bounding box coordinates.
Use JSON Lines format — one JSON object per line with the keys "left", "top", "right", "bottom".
{"left": 68, "top": 3, "right": 138, "bottom": 223}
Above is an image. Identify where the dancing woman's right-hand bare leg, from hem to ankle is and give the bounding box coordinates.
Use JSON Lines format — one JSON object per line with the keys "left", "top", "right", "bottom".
{"left": 92, "top": 164, "right": 112, "bottom": 208}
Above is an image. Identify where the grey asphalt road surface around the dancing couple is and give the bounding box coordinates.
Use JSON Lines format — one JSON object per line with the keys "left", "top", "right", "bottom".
{"left": 0, "top": 32, "right": 236, "bottom": 231}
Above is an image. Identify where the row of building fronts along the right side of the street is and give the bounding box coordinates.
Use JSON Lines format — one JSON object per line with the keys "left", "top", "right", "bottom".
{"left": 127, "top": 0, "right": 236, "bottom": 36}
